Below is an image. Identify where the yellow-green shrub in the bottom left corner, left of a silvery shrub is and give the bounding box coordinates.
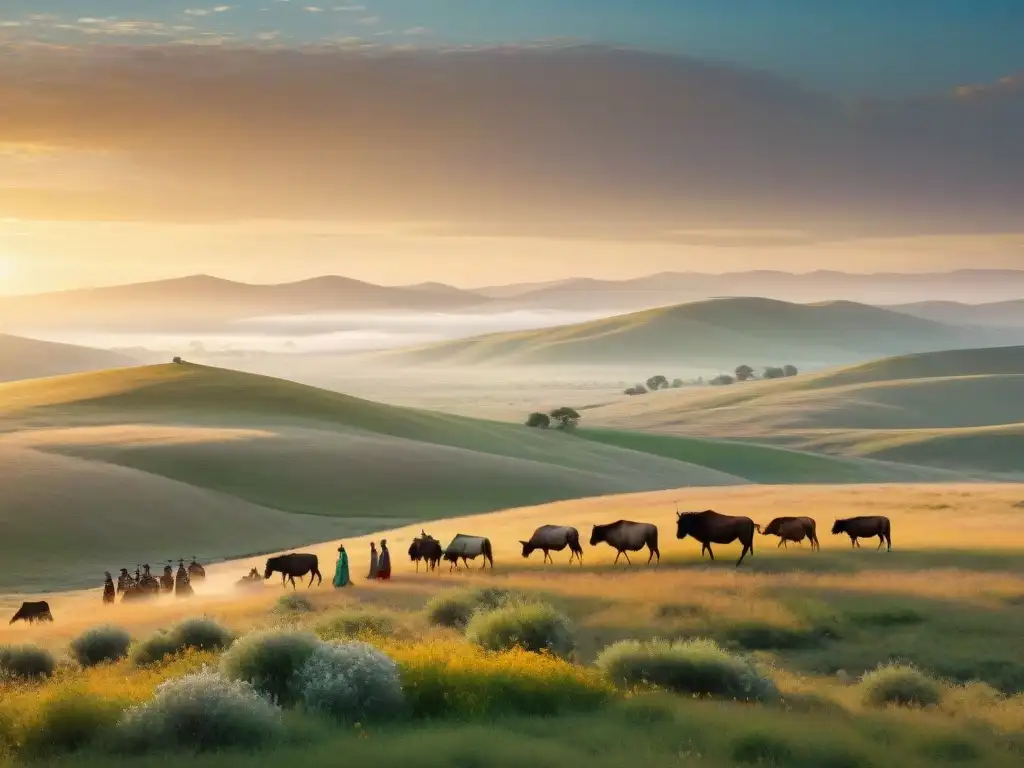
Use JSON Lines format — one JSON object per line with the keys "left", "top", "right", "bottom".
{"left": 24, "top": 689, "right": 122, "bottom": 756}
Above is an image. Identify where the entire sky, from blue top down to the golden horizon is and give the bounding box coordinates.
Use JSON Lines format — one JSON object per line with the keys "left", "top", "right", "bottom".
{"left": 0, "top": 0, "right": 1024, "bottom": 293}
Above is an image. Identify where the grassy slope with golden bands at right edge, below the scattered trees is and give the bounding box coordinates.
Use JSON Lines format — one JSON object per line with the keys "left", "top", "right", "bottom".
{"left": 587, "top": 347, "right": 1024, "bottom": 475}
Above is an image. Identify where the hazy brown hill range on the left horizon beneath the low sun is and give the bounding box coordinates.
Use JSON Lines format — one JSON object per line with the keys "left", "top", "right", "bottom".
{"left": 0, "top": 274, "right": 487, "bottom": 331}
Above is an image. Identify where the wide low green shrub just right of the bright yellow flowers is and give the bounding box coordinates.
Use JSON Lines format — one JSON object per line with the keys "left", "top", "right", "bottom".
{"left": 597, "top": 640, "right": 778, "bottom": 701}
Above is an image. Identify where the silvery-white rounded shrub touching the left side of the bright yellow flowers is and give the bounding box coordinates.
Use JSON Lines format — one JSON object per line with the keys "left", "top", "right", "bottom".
{"left": 297, "top": 643, "right": 404, "bottom": 723}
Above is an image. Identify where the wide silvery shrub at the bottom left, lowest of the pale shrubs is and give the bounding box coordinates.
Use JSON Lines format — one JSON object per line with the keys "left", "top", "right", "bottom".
{"left": 118, "top": 670, "right": 282, "bottom": 752}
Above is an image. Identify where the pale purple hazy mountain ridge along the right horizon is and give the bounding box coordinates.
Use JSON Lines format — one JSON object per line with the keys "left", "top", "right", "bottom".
{"left": 491, "top": 269, "right": 1024, "bottom": 309}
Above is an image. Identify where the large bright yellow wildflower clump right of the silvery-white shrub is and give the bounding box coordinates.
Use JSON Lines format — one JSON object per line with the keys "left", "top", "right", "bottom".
{"left": 384, "top": 639, "right": 613, "bottom": 720}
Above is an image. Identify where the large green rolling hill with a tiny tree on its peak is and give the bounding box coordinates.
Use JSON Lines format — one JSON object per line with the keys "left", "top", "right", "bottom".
{"left": 0, "top": 365, "right": 967, "bottom": 591}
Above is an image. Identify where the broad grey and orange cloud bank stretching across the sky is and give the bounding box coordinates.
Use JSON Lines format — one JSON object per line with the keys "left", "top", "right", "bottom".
{"left": 0, "top": 44, "right": 1024, "bottom": 232}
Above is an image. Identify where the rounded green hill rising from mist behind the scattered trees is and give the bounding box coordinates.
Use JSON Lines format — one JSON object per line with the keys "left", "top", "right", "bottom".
{"left": 376, "top": 298, "right": 1001, "bottom": 371}
